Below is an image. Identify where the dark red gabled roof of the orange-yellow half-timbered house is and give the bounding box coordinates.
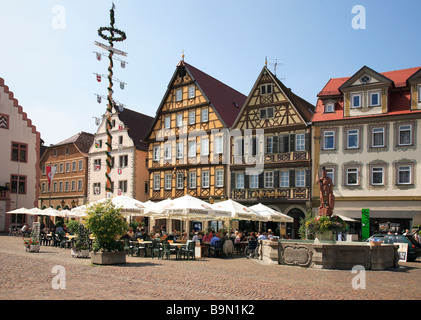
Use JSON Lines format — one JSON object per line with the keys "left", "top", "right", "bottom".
{"left": 146, "top": 61, "right": 247, "bottom": 139}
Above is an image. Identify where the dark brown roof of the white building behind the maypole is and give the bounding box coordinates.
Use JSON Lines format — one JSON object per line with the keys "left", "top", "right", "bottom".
{"left": 118, "top": 108, "right": 154, "bottom": 151}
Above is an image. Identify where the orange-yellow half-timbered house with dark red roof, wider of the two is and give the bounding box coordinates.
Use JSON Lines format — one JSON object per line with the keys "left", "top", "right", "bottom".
{"left": 146, "top": 61, "right": 246, "bottom": 208}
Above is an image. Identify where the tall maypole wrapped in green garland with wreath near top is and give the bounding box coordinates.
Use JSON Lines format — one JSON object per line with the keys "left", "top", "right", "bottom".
{"left": 95, "top": 3, "right": 127, "bottom": 198}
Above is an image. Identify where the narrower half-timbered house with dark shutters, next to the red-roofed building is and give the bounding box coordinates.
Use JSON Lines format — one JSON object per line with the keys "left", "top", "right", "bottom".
{"left": 230, "top": 66, "right": 314, "bottom": 238}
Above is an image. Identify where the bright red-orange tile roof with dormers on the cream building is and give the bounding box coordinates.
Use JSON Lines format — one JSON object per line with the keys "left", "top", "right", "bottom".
{"left": 312, "top": 67, "right": 421, "bottom": 122}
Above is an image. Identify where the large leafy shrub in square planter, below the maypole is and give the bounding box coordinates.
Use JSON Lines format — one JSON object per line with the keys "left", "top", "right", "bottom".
{"left": 86, "top": 199, "right": 127, "bottom": 264}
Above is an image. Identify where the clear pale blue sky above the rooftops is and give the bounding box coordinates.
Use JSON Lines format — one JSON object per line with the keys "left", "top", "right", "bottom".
{"left": 0, "top": 0, "right": 421, "bottom": 145}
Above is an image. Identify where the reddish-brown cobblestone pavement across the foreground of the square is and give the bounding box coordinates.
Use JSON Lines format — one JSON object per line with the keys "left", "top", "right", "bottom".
{"left": 0, "top": 235, "right": 421, "bottom": 300}
